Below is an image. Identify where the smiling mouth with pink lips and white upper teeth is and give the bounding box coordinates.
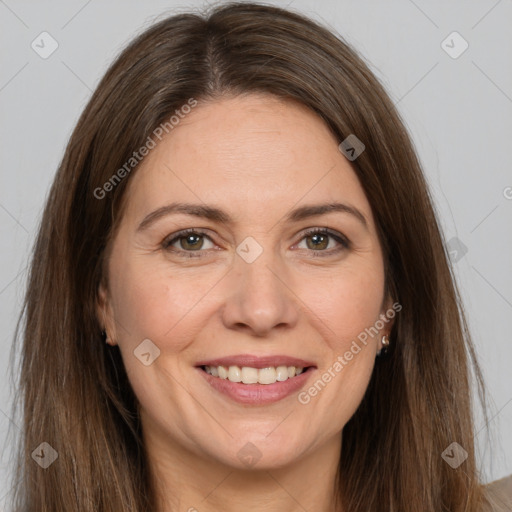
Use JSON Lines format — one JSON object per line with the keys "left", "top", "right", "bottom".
{"left": 196, "top": 355, "right": 316, "bottom": 405}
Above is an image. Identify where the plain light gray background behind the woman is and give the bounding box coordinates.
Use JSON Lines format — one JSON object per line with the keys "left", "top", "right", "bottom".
{"left": 0, "top": 0, "right": 512, "bottom": 504}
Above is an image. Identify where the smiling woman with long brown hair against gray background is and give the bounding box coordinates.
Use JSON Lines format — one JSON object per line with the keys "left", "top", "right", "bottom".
{"left": 6, "top": 4, "right": 510, "bottom": 512}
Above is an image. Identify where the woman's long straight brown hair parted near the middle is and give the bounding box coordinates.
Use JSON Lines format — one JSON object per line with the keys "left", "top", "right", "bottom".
{"left": 7, "top": 3, "right": 484, "bottom": 512}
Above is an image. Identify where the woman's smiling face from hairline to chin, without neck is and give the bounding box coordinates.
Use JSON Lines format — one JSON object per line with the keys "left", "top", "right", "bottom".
{"left": 100, "top": 95, "right": 391, "bottom": 468}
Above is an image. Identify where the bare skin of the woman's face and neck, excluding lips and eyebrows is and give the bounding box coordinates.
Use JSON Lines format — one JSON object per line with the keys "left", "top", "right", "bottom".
{"left": 98, "top": 94, "right": 392, "bottom": 512}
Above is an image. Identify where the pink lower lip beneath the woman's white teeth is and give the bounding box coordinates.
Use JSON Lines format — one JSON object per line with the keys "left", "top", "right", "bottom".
{"left": 197, "top": 367, "right": 315, "bottom": 405}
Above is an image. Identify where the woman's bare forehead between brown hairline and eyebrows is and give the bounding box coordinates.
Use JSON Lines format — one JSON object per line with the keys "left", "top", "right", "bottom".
{"left": 122, "top": 94, "right": 370, "bottom": 224}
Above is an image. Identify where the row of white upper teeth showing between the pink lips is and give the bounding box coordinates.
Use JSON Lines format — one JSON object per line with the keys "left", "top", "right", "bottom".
{"left": 203, "top": 366, "right": 304, "bottom": 384}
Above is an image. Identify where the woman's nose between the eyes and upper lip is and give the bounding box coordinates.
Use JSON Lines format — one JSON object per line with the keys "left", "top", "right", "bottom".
{"left": 222, "top": 250, "right": 300, "bottom": 337}
